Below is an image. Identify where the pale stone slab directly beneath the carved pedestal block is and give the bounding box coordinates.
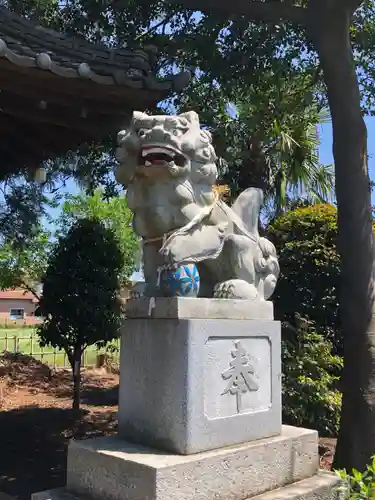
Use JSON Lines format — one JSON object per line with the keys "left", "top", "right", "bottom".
{"left": 67, "top": 426, "right": 319, "bottom": 500}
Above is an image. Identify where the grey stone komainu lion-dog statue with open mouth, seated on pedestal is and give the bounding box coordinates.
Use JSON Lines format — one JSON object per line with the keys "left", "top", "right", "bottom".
{"left": 116, "top": 111, "right": 279, "bottom": 300}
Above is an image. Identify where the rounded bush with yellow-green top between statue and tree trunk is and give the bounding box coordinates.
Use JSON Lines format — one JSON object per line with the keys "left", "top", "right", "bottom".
{"left": 267, "top": 205, "right": 343, "bottom": 354}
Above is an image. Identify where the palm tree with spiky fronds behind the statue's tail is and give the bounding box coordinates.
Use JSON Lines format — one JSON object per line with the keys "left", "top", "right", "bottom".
{"left": 219, "top": 82, "right": 334, "bottom": 218}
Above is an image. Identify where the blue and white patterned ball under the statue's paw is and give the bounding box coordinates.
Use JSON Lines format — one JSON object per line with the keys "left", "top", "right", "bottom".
{"left": 160, "top": 264, "right": 200, "bottom": 297}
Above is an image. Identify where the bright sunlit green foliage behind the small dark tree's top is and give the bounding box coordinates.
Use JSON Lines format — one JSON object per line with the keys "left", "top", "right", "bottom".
{"left": 58, "top": 189, "right": 139, "bottom": 285}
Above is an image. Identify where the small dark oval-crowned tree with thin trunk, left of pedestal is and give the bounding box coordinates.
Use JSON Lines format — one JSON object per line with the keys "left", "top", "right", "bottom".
{"left": 38, "top": 219, "right": 123, "bottom": 408}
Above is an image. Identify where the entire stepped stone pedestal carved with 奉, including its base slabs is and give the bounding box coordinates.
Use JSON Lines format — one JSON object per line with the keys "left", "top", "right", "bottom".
{"left": 33, "top": 299, "right": 344, "bottom": 500}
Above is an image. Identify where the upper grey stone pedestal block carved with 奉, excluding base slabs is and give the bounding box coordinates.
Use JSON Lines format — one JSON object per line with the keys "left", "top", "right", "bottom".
{"left": 119, "top": 298, "right": 281, "bottom": 454}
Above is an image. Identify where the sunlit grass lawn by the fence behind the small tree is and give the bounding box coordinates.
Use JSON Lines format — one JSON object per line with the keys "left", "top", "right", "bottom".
{"left": 0, "top": 328, "right": 116, "bottom": 368}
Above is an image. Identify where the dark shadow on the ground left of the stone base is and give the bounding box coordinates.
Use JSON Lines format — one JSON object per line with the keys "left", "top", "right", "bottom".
{"left": 0, "top": 406, "right": 116, "bottom": 500}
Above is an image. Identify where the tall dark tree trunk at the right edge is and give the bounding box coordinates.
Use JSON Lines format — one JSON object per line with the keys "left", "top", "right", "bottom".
{"left": 308, "top": 0, "right": 375, "bottom": 471}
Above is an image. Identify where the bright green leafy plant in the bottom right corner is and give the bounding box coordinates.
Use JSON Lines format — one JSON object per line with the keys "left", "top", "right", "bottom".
{"left": 335, "top": 455, "right": 375, "bottom": 500}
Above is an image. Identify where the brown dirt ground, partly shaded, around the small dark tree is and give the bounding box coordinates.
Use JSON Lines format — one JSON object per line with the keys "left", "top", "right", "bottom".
{"left": 0, "top": 355, "right": 335, "bottom": 500}
